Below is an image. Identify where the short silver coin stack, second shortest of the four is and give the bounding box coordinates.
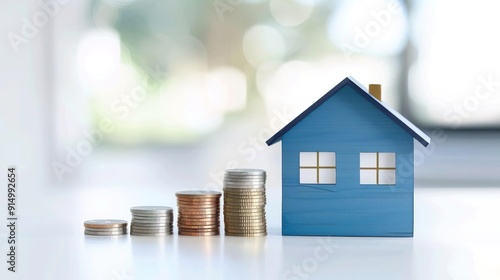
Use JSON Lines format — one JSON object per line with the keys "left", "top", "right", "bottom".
{"left": 130, "top": 206, "right": 174, "bottom": 236}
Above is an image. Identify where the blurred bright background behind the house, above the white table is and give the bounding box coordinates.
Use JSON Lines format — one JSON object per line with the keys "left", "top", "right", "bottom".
{"left": 0, "top": 0, "right": 500, "bottom": 192}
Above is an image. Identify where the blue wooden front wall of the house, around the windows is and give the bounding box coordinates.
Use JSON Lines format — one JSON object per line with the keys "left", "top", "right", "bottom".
{"left": 282, "top": 85, "right": 414, "bottom": 236}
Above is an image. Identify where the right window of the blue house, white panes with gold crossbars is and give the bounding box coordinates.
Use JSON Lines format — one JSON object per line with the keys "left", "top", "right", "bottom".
{"left": 359, "top": 152, "right": 396, "bottom": 185}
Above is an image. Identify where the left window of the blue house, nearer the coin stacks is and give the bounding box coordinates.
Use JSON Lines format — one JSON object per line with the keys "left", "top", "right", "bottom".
{"left": 299, "top": 152, "right": 337, "bottom": 185}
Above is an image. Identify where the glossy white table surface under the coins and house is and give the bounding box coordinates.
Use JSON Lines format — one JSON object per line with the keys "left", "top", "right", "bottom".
{"left": 0, "top": 182, "right": 500, "bottom": 280}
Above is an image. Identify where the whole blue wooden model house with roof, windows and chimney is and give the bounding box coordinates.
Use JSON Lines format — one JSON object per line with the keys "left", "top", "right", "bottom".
{"left": 266, "top": 77, "right": 430, "bottom": 236}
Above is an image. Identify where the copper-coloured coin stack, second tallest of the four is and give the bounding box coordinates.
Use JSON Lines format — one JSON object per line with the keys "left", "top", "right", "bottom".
{"left": 175, "top": 191, "right": 222, "bottom": 236}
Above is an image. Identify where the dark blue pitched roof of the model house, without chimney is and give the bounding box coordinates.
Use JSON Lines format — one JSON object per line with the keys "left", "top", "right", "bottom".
{"left": 266, "top": 77, "right": 431, "bottom": 147}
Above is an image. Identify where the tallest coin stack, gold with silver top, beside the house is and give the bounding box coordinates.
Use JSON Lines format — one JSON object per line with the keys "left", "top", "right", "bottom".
{"left": 224, "top": 169, "right": 267, "bottom": 236}
